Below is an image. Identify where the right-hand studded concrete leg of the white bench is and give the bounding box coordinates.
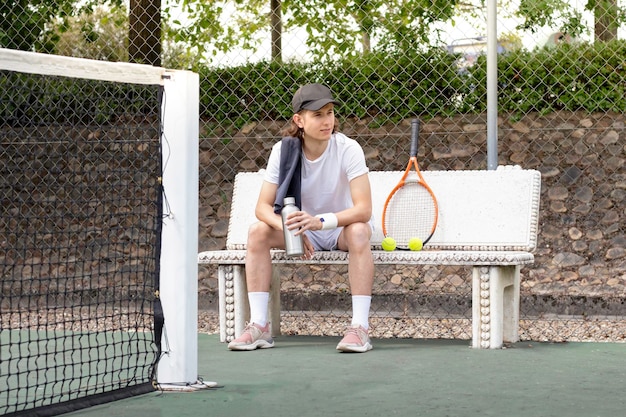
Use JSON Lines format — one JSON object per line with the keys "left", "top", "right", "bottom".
{"left": 472, "top": 265, "right": 520, "bottom": 349}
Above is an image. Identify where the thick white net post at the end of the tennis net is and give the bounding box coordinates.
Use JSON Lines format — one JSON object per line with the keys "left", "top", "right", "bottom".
{"left": 157, "top": 71, "right": 199, "bottom": 389}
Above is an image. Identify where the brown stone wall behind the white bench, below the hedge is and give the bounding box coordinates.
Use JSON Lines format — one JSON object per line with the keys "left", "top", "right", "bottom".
{"left": 199, "top": 112, "right": 626, "bottom": 307}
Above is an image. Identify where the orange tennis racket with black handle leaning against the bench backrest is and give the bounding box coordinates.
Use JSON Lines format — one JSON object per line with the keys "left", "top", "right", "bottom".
{"left": 382, "top": 119, "right": 439, "bottom": 250}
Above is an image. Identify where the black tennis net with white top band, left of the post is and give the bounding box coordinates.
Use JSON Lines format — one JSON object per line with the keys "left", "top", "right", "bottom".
{"left": 0, "top": 49, "right": 163, "bottom": 416}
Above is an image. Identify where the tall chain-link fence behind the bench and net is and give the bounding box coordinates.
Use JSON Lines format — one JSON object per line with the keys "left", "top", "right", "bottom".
{"left": 0, "top": 0, "right": 626, "bottom": 341}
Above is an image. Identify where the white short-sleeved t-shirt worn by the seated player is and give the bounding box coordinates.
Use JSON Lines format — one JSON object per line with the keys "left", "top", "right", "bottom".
{"left": 265, "top": 133, "right": 369, "bottom": 215}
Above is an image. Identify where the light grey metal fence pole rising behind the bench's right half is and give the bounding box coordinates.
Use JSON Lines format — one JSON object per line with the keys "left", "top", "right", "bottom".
{"left": 487, "top": 0, "right": 498, "bottom": 170}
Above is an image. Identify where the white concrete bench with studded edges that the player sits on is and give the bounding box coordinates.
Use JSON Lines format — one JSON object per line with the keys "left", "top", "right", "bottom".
{"left": 198, "top": 166, "right": 541, "bottom": 348}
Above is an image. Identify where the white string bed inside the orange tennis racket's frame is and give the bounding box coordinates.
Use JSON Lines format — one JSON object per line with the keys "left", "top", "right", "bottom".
{"left": 385, "top": 183, "right": 436, "bottom": 246}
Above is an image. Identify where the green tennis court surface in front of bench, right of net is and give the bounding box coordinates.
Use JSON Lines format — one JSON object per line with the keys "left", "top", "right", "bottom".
{"left": 66, "top": 334, "right": 626, "bottom": 417}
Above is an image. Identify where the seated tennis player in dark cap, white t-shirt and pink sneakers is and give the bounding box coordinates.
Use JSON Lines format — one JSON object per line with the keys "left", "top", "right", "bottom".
{"left": 228, "top": 84, "right": 374, "bottom": 352}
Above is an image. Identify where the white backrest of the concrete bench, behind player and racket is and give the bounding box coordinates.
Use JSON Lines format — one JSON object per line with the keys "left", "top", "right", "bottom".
{"left": 226, "top": 166, "right": 541, "bottom": 251}
